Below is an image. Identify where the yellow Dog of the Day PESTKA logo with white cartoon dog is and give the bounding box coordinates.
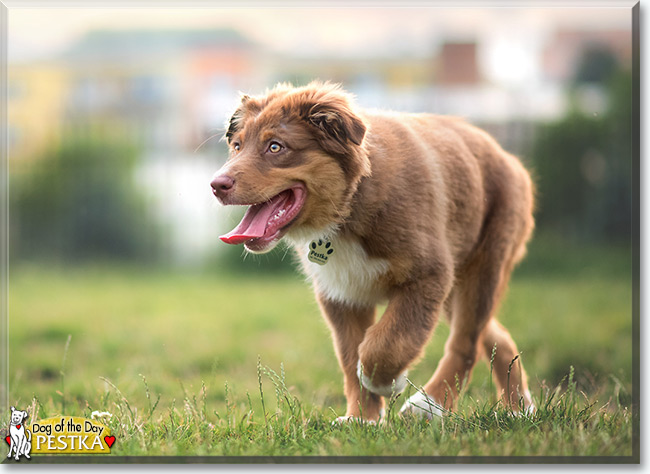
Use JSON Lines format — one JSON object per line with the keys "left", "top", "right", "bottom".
{"left": 6, "top": 407, "right": 115, "bottom": 461}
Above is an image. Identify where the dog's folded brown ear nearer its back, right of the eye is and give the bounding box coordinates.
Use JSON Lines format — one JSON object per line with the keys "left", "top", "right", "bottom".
{"left": 306, "top": 90, "right": 366, "bottom": 154}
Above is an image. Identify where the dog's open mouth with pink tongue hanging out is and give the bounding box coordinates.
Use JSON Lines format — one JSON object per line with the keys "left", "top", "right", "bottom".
{"left": 219, "top": 184, "right": 307, "bottom": 251}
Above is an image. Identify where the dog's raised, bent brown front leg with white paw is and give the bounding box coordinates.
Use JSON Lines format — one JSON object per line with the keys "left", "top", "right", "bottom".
{"left": 359, "top": 276, "right": 451, "bottom": 397}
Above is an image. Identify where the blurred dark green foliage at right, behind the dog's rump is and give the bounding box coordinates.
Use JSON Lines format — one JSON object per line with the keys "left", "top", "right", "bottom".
{"left": 531, "top": 50, "right": 632, "bottom": 243}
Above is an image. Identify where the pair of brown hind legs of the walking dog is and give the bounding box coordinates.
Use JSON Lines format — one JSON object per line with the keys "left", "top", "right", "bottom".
{"left": 404, "top": 202, "right": 530, "bottom": 412}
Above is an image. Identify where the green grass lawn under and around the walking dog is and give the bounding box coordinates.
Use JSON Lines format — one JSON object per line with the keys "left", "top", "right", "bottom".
{"left": 2, "top": 244, "right": 633, "bottom": 456}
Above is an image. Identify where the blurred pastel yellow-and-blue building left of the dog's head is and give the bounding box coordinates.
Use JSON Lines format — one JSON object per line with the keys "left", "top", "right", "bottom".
{"left": 9, "top": 30, "right": 254, "bottom": 160}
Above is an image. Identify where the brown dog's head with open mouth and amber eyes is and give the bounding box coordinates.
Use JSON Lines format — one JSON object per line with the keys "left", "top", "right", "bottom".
{"left": 211, "top": 83, "right": 370, "bottom": 253}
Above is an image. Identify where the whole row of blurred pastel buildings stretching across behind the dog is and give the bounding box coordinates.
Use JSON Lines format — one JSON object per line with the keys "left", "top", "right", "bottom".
{"left": 9, "top": 29, "right": 631, "bottom": 160}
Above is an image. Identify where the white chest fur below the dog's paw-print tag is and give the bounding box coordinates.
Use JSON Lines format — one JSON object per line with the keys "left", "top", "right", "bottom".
{"left": 292, "top": 231, "right": 389, "bottom": 305}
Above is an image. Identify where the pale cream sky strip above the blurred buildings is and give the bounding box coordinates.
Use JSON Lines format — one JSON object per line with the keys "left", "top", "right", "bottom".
{"left": 9, "top": 7, "right": 631, "bottom": 60}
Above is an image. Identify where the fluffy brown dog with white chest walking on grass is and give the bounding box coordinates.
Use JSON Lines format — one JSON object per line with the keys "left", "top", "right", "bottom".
{"left": 211, "top": 83, "right": 534, "bottom": 420}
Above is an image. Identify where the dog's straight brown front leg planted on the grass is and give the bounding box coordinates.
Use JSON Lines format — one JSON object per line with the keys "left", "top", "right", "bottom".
{"left": 317, "top": 295, "right": 383, "bottom": 420}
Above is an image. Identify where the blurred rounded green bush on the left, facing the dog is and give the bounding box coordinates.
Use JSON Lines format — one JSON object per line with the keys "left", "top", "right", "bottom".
{"left": 10, "top": 137, "right": 160, "bottom": 261}
